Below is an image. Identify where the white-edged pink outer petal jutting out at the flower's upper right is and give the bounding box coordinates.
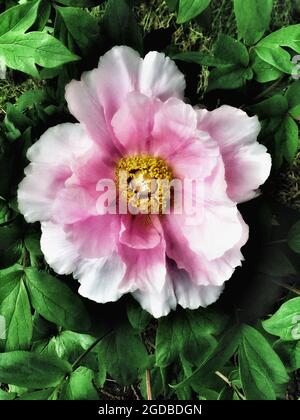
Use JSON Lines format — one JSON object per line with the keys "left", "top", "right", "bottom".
{"left": 198, "top": 105, "right": 271, "bottom": 202}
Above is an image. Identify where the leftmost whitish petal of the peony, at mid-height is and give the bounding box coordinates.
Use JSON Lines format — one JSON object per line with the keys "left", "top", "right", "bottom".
{"left": 18, "top": 163, "right": 71, "bottom": 223}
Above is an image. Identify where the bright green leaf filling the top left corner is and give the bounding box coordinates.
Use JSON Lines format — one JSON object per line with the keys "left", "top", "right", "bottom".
{"left": 0, "top": 0, "right": 40, "bottom": 37}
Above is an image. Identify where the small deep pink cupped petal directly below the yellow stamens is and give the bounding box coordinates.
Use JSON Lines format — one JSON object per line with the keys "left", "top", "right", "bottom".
{"left": 120, "top": 214, "right": 162, "bottom": 249}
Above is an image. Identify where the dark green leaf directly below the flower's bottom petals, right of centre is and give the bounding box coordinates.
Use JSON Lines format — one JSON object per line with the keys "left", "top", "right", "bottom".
{"left": 156, "top": 311, "right": 216, "bottom": 368}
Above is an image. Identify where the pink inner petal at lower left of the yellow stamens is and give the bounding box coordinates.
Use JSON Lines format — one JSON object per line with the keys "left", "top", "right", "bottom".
{"left": 65, "top": 214, "right": 120, "bottom": 258}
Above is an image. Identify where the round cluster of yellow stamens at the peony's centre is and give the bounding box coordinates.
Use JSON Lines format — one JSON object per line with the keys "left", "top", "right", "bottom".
{"left": 116, "top": 155, "right": 173, "bottom": 214}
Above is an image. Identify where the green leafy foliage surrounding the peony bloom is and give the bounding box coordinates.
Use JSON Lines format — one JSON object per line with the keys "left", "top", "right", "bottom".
{"left": 0, "top": 0, "right": 300, "bottom": 400}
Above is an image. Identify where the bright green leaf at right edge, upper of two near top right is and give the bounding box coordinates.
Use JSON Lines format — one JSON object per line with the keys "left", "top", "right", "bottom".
{"left": 258, "top": 24, "right": 300, "bottom": 53}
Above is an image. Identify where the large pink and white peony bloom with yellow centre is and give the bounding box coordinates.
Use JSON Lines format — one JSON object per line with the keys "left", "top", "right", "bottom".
{"left": 18, "top": 47, "right": 271, "bottom": 317}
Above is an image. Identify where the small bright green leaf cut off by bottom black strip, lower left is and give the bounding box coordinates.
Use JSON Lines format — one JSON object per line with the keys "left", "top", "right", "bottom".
{"left": 60, "top": 367, "right": 99, "bottom": 400}
